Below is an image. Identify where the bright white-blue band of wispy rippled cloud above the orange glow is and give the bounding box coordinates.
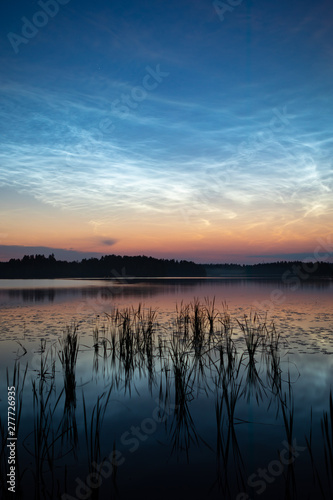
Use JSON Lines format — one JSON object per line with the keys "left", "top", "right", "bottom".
{"left": 0, "top": 89, "right": 332, "bottom": 232}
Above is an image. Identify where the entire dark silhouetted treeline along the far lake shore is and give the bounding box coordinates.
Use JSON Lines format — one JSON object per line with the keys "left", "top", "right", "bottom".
{"left": 0, "top": 254, "right": 333, "bottom": 281}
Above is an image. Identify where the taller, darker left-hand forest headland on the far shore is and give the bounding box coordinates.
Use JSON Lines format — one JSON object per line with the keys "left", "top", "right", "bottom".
{"left": 0, "top": 254, "right": 206, "bottom": 279}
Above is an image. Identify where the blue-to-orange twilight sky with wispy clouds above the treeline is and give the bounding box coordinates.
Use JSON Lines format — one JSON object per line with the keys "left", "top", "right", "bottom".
{"left": 0, "top": 0, "right": 333, "bottom": 263}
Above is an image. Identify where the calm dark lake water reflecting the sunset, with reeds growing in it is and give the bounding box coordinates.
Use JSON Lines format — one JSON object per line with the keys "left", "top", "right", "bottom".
{"left": 0, "top": 279, "right": 333, "bottom": 500}
